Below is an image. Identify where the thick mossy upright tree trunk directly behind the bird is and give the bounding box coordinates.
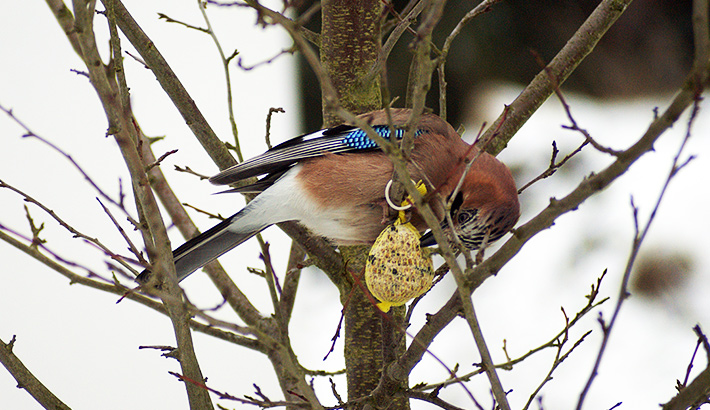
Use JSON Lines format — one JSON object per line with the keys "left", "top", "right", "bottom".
{"left": 320, "top": 0, "right": 409, "bottom": 409}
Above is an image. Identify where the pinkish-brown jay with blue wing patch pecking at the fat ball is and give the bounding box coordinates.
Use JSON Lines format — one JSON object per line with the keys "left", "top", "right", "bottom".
{"left": 137, "top": 108, "right": 520, "bottom": 283}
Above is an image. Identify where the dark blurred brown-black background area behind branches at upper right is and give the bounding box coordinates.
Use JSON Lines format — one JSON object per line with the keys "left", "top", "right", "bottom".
{"left": 294, "top": 0, "right": 693, "bottom": 130}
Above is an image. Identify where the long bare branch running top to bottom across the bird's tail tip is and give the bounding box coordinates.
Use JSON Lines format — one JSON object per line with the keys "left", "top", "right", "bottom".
{"left": 74, "top": 0, "right": 212, "bottom": 408}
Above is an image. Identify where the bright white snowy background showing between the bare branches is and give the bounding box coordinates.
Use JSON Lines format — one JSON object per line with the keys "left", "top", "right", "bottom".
{"left": 0, "top": 1, "right": 710, "bottom": 409}
